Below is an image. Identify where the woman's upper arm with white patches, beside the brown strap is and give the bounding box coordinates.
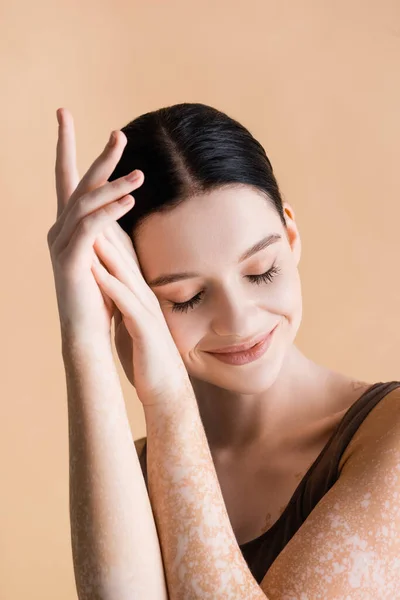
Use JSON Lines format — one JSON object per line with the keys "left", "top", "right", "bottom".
{"left": 260, "top": 388, "right": 400, "bottom": 600}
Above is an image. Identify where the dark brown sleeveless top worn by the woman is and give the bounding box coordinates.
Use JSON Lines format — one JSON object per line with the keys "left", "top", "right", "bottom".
{"left": 135, "top": 381, "right": 400, "bottom": 583}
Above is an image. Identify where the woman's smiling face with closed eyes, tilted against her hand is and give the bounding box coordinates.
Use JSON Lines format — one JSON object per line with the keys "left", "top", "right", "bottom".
{"left": 133, "top": 186, "right": 302, "bottom": 394}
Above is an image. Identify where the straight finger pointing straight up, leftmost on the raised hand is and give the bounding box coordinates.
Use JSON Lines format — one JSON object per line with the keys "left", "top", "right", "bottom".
{"left": 55, "top": 108, "right": 79, "bottom": 219}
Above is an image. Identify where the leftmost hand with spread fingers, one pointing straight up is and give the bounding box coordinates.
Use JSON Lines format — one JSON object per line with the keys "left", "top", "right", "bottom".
{"left": 47, "top": 109, "right": 143, "bottom": 338}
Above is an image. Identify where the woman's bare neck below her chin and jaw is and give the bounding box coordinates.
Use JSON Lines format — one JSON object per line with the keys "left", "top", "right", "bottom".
{"left": 190, "top": 345, "right": 333, "bottom": 453}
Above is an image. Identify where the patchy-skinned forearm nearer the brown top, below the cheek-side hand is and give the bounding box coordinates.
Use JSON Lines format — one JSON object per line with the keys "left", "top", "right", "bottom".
{"left": 144, "top": 380, "right": 266, "bottom": 600}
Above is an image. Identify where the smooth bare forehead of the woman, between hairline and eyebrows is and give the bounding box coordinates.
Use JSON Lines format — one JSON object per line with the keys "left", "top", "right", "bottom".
{"left": 133, "top": 186, "right": 282, "bottom": 268}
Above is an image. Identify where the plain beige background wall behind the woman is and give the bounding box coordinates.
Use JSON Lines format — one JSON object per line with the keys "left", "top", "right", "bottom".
{"left": 0, "top": 0, "right": 400, "bottom": 600}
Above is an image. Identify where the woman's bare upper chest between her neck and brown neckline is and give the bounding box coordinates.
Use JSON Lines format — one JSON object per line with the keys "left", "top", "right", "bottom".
{"left": 212, "top": 382, "right": 370, "bottom": 544}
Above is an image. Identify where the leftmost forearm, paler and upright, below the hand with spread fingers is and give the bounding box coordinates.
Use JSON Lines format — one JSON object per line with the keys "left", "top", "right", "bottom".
{"left": 62, "top": 335, "right": 168, "bottom": 600}
